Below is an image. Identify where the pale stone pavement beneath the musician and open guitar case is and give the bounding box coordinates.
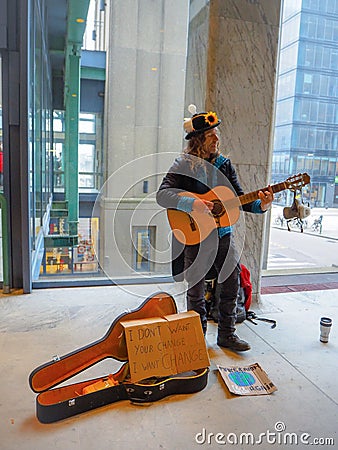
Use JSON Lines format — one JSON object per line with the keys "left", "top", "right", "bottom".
{"left": 0, "top": 283, "right": 338, "bottom": 450}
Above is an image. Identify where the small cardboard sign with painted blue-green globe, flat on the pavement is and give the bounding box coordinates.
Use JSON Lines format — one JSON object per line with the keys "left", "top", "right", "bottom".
{"left": 217, "top": 363, "right": 277, "bottom": 395}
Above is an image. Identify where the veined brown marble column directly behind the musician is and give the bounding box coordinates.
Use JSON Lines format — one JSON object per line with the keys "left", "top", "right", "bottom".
{"left": 186, "top": 0, "right": 281, "bottom": 300}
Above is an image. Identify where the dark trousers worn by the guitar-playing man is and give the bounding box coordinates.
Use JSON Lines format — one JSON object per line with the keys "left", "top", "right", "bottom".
{"left": 184, "top": 231, "right": 240, "bottom": 337}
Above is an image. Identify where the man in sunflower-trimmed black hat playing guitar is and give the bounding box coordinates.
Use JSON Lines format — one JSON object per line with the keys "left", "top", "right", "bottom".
{"left": 156, "top": 105, "right": 274, "bottom": 351}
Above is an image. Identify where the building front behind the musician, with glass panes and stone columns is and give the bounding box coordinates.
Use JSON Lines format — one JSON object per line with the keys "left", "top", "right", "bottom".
{"left": 0, "top": 0, "right": 280, "bottom": 294}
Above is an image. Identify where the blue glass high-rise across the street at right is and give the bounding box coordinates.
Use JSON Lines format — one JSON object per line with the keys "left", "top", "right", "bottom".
{"left": 272, "top": 0, "right": 338, "bottom": 207}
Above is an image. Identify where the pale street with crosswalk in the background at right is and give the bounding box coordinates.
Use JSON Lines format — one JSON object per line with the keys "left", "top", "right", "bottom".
{"left": 267, "top": 206, "right": 338, "bottom": 270}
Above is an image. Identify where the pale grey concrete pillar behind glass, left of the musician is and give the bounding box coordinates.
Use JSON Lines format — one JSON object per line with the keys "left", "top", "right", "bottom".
{"left": 100, "top": 0, "right": 189, "bottom": 276}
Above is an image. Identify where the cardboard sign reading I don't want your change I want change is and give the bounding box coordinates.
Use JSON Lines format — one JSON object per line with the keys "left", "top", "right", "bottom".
{"left": 121, "top": 311, "right": 210, "bottom": 382}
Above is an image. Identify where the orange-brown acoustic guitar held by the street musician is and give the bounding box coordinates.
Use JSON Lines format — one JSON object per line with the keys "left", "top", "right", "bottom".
{"left": 167, "top": 173, "right": 310, "bottom": 245}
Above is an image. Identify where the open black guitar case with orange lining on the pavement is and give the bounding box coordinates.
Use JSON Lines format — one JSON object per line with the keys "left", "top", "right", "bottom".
{"left": 29, "top": 292, "right": 209, "bottom": 423}
